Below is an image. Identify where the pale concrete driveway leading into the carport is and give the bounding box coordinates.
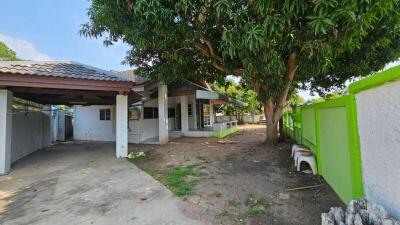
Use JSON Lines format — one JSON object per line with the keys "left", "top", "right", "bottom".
{"left": 0, "top": 142, "right": 202, "bottom": 225}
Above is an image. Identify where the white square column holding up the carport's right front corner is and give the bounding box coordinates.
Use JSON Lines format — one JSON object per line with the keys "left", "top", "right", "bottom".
{"left": 115, "top": 95, "right": 128, "bottom": 158}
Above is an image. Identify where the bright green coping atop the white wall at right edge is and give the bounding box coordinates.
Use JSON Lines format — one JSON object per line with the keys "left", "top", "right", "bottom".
{"left": 348, "top": 66, "right": 400, "bottom": 94}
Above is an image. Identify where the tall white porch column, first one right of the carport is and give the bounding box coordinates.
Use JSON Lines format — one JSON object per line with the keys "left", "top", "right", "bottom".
{"left": 158, "top": 83, "right": 168, "bottom": 145}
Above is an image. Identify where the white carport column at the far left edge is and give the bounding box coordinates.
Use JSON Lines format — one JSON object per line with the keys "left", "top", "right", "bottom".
{"left": 0, "top": 90, "right": 13, "bottom": 175}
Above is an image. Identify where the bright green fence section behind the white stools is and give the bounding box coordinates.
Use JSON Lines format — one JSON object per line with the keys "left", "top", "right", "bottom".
{"left": 284, "top": 95, "right": 363, "bottom": 203}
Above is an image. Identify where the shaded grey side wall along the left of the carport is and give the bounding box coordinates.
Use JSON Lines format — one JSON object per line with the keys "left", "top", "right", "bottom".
{"left": 11, "top": 112, "right": 52, "bottom": 163}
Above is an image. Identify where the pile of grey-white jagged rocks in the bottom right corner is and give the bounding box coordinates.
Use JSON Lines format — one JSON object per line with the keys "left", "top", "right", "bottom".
{"left": 321, "top": 199, "right": 400, "bottom": 225}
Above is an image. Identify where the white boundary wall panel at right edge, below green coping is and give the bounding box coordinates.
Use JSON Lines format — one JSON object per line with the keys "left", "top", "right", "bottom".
{"left": 356, "top": 81, "right": 400, "bottom": 218}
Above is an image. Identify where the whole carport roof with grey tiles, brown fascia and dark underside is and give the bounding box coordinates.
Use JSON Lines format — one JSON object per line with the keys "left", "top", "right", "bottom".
{"left": 0, "top": 61, "right": 138, "bottom": 105}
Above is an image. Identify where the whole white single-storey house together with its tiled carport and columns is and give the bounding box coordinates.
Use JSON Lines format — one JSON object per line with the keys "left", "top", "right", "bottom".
{"left": 0, "top": 61, "right": 243, "bottom": 175}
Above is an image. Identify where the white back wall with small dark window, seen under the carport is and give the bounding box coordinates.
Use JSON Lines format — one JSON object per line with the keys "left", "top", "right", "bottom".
{"left": 73, "top": 105, "right": 115, "bottom": 141}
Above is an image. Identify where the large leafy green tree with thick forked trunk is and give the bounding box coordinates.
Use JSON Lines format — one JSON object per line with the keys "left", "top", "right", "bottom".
{"left": 81, "top": 0, "right": 400, "bottom": 142}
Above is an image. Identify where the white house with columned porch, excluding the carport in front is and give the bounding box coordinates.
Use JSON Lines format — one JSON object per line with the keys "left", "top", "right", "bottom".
{"left": 74, "top": 71, "right": 244, "bottom": 144}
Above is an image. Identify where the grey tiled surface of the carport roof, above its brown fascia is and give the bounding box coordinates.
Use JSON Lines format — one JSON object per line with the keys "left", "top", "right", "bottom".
{"left": 0, "top": 61, "right": 132, "bottom": 82}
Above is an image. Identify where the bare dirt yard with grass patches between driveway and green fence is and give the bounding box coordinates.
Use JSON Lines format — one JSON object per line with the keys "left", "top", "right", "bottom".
{"left": 130, "top": 125, "right": 343, "bottom": 225}
